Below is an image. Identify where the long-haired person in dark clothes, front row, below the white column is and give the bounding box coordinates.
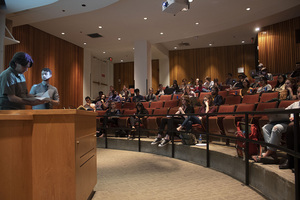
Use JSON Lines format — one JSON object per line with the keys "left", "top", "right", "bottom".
{"left": 128, "top": 102, "right": 149, "bottom": 139}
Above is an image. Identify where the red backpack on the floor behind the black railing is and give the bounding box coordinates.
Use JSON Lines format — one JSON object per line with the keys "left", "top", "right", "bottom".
{"left": 235, "top": 122, "right": 259, "bottom": 157}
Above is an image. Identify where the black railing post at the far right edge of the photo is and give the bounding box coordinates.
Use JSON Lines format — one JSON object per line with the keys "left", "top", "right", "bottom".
{"left": 294, "top": 113, "right": 300, "bottom": 200}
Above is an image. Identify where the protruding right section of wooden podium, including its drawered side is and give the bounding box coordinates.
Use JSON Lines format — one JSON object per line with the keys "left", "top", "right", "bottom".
{"left": 0, "top": 110, "right": 97, "bottom": 200}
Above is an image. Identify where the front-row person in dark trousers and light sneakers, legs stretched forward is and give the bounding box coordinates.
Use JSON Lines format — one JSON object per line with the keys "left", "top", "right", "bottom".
{"left": 151, "top": 95, "right": 194, "bottom": 147}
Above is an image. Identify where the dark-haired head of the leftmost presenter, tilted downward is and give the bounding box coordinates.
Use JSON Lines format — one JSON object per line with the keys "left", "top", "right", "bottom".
{"left": 9, "top": 52, "right": 33, "bottom": 74}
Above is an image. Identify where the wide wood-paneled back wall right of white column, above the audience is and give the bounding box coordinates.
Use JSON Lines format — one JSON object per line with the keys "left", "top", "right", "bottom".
{"left": 169, "top": 44, "right": 255, "bottom": 84}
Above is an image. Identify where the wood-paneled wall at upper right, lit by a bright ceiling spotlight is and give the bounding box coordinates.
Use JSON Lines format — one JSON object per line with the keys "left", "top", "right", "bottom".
{"left": 258, "top": 17, "right": 300, "bottom": 74}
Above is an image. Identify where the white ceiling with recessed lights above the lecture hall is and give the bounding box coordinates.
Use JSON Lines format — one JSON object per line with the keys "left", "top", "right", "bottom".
{"left": 6, "top": 0, "right": 300, "bottom": 63}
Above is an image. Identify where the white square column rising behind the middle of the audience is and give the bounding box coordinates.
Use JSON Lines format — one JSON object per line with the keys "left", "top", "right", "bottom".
{"left": 134, "top": 40, "right": 152, "bottom": 95}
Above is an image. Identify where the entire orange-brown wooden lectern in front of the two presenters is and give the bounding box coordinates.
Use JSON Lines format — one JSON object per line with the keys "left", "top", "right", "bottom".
{"left": 0, "top": 109, "right": 97, "bottom": 200}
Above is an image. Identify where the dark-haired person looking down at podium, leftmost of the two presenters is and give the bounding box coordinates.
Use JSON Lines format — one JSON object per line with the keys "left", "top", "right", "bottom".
{"left": 0, "top": 52, "right": 48, "bottom": 110}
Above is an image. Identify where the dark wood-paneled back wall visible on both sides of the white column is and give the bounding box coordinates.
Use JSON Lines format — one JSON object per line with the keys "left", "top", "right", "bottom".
{"left": 114, "top": 60, "right": 159, "bottom": 92}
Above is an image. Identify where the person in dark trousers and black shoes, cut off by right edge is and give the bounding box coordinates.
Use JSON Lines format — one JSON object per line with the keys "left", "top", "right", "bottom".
{"left": 279, "top": 86, "right": 300, "bottom": 170}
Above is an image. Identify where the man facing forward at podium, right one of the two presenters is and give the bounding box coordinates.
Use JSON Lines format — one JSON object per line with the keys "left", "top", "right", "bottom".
{"left": 30, "top": 68, "right": 59, "bottom": 110}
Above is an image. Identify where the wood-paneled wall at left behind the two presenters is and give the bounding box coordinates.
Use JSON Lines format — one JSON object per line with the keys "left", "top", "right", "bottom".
{"left": 4, "top": 25, "right": 83, "bottom": 108}
